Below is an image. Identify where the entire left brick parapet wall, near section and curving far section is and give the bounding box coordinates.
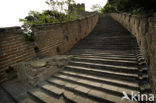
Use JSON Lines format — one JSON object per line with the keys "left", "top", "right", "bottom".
{"left": 0, "top": 13, "right": 98, "bottom": 81}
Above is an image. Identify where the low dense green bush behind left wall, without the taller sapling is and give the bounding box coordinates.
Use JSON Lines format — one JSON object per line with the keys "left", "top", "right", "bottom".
{"left": 20, "top": 10, "right": 67, "bottom": 26}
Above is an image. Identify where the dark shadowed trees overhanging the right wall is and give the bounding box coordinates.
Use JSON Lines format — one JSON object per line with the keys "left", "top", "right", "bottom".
{"left": 101, "top": 0, "right": 156, "bottom": 16}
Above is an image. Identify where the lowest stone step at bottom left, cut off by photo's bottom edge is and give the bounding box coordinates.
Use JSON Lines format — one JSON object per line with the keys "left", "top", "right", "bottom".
{"left": 29, "top": 90, "right": 65, "bottom": 103}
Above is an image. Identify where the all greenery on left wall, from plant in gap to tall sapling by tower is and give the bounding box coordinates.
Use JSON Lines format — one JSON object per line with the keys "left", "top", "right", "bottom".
{"left": 19, "top": 0, "right": 77, "bottom": 41}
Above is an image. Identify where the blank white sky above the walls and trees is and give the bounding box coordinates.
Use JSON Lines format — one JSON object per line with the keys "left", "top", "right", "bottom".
{"left": 0, "top": 0, "right": 107, "bottom": 27}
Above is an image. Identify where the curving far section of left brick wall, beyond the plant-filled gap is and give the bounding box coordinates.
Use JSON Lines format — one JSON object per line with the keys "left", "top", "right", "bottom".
{"left": 33, "top": 13, "right": 98, "bottom": 56}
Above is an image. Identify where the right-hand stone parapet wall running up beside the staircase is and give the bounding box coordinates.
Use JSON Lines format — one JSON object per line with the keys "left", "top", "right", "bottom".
{"left": 110, "top": 13, "right": 156, "bottom": 94}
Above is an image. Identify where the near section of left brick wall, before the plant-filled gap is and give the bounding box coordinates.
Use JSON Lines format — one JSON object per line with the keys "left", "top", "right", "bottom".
{"left": 0, "top": 27, "right": 35, "bottom": 81}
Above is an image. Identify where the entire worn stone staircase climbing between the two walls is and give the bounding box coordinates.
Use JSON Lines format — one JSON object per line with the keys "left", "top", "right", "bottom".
{"left": 0, "top": 16, "right": 151, "bottom": 103}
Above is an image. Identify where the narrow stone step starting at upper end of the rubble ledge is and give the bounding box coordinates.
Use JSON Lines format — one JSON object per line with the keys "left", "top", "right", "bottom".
{"left": 72, "top": 57, "right": 138, "bottom": 67}
